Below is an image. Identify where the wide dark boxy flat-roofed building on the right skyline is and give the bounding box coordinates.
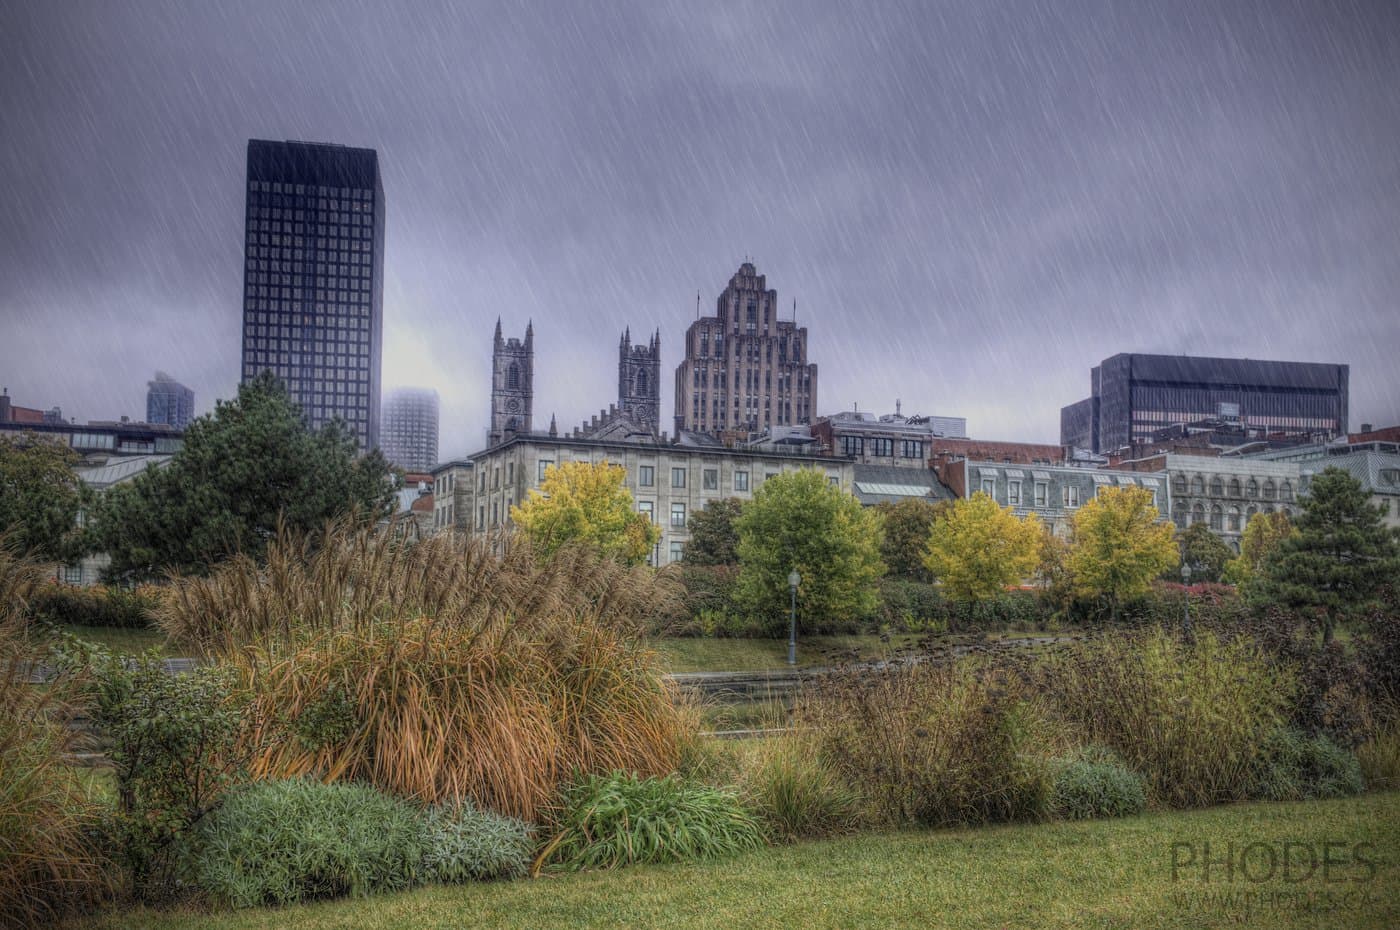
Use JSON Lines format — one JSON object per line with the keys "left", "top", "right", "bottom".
{"left": 1060, "top": 353, "right": 1350, "bottom": 452}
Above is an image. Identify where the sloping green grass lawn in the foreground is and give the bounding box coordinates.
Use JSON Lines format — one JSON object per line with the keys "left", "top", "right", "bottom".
{"left": 83, "top": 793, "right": 1400, "bottom": 930}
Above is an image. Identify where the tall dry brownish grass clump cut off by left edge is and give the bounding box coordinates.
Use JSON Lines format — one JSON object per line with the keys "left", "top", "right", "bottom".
{"left": 0, "top": 545, "right": 112, "bottom": 926}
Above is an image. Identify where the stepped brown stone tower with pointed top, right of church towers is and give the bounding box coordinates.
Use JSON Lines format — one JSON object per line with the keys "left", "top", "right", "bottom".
{"left": 675, "top": 262, "right": 816, "bottom": 436}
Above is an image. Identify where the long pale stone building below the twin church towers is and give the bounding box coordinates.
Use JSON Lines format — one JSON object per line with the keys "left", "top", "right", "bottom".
{"left": 448, "top": 434, "right": 854, "bottom": 566}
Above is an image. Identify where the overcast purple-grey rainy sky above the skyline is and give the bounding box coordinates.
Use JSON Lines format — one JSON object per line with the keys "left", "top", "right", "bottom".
{"left": 0, "top": 0, "right": 1400, "bottom": 458}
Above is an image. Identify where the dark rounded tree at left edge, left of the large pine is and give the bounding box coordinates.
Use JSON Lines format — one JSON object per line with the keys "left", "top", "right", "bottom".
{"left": 0, "top": 433, "right": 87, "bottom": 562}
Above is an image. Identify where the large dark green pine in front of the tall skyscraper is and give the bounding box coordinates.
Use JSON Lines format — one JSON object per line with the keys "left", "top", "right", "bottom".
{"left": 94, "top": 373, "right": 396, "bottom": 580}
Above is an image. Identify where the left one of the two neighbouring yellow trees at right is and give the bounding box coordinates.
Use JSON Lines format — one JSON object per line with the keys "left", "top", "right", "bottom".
{"left": 924, "top": 492, "right": 1044, "bottom": 602}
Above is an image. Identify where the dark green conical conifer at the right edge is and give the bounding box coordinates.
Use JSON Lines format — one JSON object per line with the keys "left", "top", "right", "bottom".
{"left": 1253, "top": 466, "right": 1400, "bottom": 644}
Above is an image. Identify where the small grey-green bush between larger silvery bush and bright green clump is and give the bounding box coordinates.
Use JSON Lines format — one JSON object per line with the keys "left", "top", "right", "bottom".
{"left": 423, "top": 804, "right": 533, "bottom": 884}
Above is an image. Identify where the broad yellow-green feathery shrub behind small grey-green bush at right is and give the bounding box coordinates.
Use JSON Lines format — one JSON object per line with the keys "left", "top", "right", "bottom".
{"left": 1032, "top": 629, "right": 1294, "bottom": 807}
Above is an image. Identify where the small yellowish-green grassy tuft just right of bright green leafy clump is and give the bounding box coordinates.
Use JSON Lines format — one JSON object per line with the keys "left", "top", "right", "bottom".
{"left": 741, "top": 735, "right": 861, "bottom": 840}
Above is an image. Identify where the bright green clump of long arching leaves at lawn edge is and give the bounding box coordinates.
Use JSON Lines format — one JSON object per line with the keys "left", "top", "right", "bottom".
{"left": 535, "top": 772, "right": 763, "bottom": 870}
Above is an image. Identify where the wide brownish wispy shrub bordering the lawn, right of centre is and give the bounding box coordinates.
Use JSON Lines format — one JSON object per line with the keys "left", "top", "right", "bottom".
{"left": 797, "top": 660, "right": 1051, "bottom": 825}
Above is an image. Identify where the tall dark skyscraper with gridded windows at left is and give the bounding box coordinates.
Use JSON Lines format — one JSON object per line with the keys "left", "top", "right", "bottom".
{"left": 242, "top": 139, "right": 384, "bottom": 450}
